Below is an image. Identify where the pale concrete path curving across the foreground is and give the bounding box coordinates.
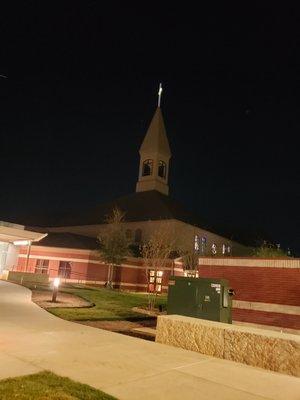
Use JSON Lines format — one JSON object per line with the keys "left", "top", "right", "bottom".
{"left": 0, "top": 281, "right": 300, "bottom": 400}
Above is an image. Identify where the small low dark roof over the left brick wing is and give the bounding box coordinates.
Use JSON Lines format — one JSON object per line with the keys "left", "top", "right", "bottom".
{"left": 34, "top": 232, "right": 99, "bottom": 250}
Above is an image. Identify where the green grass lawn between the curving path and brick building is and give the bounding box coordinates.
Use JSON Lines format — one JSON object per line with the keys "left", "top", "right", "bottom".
{"left": 23, "top": 286, "right": 167, "bottom": 321}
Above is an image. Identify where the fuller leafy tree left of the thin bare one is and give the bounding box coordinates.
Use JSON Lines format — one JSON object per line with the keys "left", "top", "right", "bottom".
{"left": 98, "top": 208, "right": 131, "bottom": 288}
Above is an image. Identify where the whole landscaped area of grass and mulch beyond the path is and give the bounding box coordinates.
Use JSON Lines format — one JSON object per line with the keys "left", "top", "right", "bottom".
{"left": 19, "top": 284, "right": 166, "bottom": 340}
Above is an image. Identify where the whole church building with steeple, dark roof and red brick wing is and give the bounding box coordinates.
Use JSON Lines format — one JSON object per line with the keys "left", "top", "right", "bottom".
{"left": 12, "top": 90, "right": 249, "bottom": 290}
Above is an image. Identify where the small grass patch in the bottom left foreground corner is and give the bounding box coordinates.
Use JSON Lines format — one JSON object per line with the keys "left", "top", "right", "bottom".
{"left": 0, "top": 371, "right": 116, "bottom": 400}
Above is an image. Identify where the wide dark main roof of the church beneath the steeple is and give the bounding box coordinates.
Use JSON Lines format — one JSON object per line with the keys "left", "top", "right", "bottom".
{"left": 26, "top": 190, "right": 255, "bottom": 244}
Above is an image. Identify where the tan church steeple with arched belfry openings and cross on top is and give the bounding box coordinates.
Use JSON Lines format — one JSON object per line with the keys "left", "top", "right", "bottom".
{"left": 136, "top": 85, "right": 171, "bottom": 195}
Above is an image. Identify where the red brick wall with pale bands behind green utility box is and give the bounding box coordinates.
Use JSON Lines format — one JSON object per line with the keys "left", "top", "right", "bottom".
{"left": 199, "top": 257, "right": 300, "bottom": 333}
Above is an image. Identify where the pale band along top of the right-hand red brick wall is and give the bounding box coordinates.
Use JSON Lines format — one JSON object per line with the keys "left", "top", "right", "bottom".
{"left": 199, "top": 257, "right": 300, "bottom": 268}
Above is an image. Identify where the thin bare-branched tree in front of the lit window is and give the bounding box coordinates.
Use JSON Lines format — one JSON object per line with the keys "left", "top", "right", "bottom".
{"left": 140, "top": 225, "right": 177, "bottom": 310}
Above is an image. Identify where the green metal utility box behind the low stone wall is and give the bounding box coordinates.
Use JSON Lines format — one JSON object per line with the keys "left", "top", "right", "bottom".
{"left": 167, "top": 276, "right": 233, "bottom": 324}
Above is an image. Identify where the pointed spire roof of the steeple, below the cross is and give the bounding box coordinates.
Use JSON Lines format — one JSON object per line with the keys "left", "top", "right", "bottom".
{"left": 140, "top": 107, "right": 171, "bottom": 157}
